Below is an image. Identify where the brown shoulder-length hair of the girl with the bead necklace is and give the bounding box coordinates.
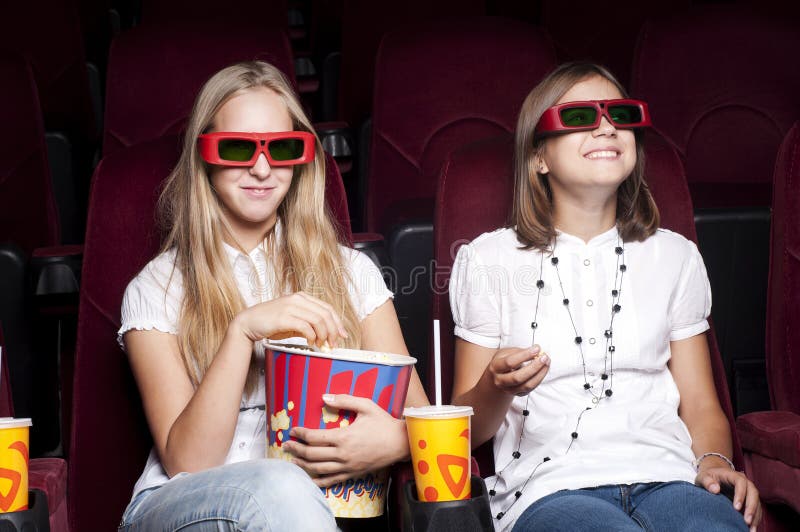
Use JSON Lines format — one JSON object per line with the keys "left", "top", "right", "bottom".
{"left": 509, "top": 62, "right": 659, "bottom": 251}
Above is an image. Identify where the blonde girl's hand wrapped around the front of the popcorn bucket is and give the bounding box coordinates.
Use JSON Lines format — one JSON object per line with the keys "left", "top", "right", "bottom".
{"left": 283, "top": 394, "right": 408, "bottom": 488}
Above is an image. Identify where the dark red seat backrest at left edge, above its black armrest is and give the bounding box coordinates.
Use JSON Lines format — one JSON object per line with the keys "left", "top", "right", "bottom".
{"left": 0, "top": 51, "right": 60, "bottom": 255}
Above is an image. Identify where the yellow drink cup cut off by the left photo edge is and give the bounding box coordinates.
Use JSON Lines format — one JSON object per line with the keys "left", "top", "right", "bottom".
{"left": 0, "top": 417, "right": 31, "bottom": 513}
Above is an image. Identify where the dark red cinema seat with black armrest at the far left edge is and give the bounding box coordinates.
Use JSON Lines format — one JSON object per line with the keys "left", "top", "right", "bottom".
{"left": 0, "top": 51, "right": 80, "bottom": 455}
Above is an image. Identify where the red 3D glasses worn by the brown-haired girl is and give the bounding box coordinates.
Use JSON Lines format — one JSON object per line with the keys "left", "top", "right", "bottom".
{"left": 535, "top": 99, "right": 652, "bottom": 135}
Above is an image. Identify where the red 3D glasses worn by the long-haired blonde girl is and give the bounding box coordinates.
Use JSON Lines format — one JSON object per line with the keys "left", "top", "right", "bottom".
{"left": 197, "top": 131, "right": 315, "bottom": 166}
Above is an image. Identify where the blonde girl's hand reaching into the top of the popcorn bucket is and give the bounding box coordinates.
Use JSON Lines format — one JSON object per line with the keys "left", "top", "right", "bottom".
{"left": 233, "top": 292, "right": 347, "bottom": 346}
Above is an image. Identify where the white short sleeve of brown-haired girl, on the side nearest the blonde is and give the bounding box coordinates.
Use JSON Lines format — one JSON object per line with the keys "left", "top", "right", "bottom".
{"left": 450, "top": 244, "right": 501, "bottom": 348}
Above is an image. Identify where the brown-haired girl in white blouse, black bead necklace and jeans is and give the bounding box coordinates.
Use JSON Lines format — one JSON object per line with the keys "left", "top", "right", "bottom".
{"left": 450, "top": 63, "right": 761, "bottom": 531}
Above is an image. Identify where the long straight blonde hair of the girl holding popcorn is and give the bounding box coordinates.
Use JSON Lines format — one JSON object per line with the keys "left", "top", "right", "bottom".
{"left": 158, "top": 61, "right": 361, "bottom": 394}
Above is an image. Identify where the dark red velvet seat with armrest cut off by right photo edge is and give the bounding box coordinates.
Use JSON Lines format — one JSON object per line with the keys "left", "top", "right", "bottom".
{"left": 737, "top": 122, "right": 800, "bottom": 530}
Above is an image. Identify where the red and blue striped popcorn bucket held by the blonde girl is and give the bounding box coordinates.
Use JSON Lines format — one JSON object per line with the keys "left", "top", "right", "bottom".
{"left": 266, "top": 344, "right": 416, "bottom": 517}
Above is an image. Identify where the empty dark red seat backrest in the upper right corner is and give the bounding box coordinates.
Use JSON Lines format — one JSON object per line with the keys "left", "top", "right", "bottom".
{"left": 631, "top": 5, "right": 800, "bottom": 207}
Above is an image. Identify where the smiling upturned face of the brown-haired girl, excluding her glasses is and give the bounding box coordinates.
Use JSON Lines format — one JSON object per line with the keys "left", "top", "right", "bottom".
{"left": 537, "top": 76, "right": 636, "bottom": 201}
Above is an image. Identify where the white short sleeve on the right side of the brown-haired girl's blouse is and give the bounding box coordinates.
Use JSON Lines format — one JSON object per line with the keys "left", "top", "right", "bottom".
{"left": 669, "top": 240, "right": 711, "bottom": 341}
